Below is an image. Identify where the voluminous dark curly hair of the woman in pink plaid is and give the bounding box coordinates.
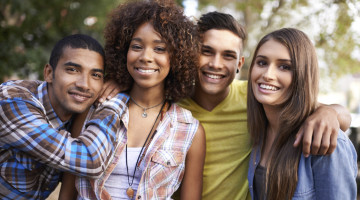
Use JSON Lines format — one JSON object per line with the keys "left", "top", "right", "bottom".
{"left": 104, "top": 0, "right": 200, "bottom": 102}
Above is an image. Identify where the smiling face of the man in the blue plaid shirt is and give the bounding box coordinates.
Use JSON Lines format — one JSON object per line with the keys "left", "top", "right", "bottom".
{"left": 44, "top": 47, "right": 104, "bottom": 121}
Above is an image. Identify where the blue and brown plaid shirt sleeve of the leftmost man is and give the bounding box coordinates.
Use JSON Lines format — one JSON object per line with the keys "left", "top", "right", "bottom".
{"left": 0, "top": 94, "right": 128, "bottom": 178}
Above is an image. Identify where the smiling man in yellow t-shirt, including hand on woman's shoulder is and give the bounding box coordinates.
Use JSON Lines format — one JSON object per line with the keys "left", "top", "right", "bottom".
{"left": 174, "top": 12, "right": 351, "bottom": 200}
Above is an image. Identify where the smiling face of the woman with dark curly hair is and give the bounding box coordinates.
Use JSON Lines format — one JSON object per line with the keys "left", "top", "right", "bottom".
{"left": 127, "top": 23, "right": 170, "bottom": 90}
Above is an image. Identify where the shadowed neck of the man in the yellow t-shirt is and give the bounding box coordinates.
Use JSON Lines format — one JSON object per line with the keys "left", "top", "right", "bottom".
{"left": 191, "top": 83, "right": 230, "bottom": 111}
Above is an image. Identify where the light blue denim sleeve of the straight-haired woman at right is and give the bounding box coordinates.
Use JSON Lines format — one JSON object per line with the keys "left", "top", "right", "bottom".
{"left": 312, "top": 131, "right": 358, "bottom": 200}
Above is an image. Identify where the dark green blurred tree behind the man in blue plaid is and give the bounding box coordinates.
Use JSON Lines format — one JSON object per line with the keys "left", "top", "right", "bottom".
{"left": 0, "top": 0, "right": 121, "bottom": 81}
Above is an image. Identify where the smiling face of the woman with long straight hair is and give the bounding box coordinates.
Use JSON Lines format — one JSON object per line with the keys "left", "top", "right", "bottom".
{"left": 250, "top": 39, "right": 293, "bottom": 106}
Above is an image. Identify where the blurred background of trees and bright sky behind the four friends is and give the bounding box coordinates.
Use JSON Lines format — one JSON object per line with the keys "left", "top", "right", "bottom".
{"left": 0, "top": 0, "right": 360, "bottom": 198}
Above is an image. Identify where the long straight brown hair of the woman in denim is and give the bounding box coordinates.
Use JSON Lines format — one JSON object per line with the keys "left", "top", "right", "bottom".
{"left": 247, "top": 28, "right": 318, "bottom": 200}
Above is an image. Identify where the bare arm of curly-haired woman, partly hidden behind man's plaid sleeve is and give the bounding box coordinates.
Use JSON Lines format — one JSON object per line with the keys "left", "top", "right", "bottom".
{"left": 59, "top": 110, "right": 89, "bottom": 200}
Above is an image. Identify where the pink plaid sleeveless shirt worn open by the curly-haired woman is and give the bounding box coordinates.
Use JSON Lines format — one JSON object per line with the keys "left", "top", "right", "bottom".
{"left": 76, "top": 104, "right": 199, "bottom": 200}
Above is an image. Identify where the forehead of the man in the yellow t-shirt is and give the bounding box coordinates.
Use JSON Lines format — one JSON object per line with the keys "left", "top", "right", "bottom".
{"left": 202, "top": 29, "right": 242, "bottom": 53}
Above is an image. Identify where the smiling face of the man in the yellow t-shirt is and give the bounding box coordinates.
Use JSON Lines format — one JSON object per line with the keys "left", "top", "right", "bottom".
{"left": 197, "top": 29, "right": 244, "bottom": 99}
